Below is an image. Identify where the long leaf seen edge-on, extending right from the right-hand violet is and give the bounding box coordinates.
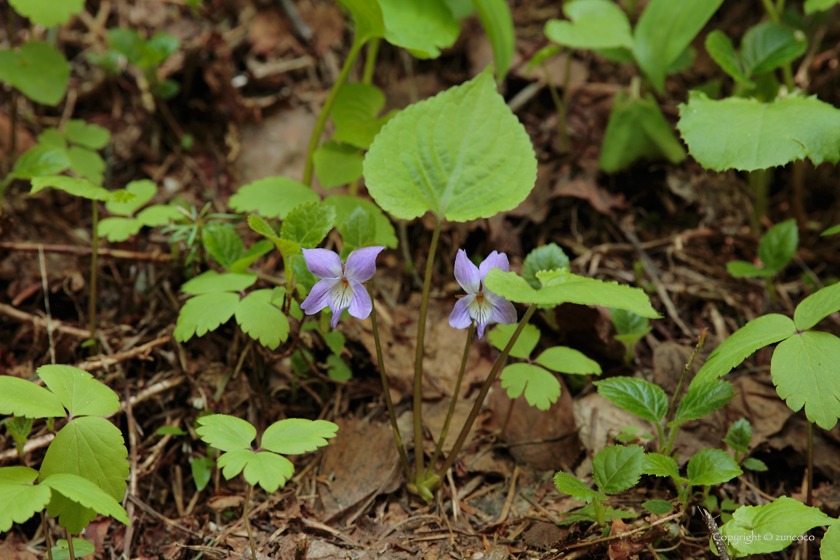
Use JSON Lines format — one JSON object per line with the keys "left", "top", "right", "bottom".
{"left": 484, "top": 268, "right": 659, "bottom": 319}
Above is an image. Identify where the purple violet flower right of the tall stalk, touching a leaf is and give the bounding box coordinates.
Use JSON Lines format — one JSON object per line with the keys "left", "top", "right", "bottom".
{"left": 449, "top": 249, "right": 516, "bottom": 339}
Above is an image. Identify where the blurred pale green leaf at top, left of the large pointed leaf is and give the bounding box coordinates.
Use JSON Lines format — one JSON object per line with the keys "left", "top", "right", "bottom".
{"left": 545, "top": 0, "right": 633, "bottom": 49}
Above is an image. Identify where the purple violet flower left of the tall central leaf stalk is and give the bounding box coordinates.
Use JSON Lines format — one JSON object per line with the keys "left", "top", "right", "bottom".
{"left": 300, "top": 247, "right": 385, "bottom": 328}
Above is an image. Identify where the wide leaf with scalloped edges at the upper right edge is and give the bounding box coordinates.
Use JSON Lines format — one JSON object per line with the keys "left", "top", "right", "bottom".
{"left": 677, "top": 91, "right": 840, "bottom": 171}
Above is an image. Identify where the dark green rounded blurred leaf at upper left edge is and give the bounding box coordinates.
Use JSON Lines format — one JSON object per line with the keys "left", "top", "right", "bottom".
{"left": 0, "top": 41, "right": 70, "bottom": 105}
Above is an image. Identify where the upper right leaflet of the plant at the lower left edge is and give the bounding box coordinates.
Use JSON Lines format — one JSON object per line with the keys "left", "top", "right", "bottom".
{"left": 38, "top": 365, "right": 120, "bottom": 416}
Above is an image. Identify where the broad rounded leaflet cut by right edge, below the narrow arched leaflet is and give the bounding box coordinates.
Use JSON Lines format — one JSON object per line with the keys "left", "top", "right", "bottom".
{"left": 770, "top": 331, "right": 840, "bottom": 430}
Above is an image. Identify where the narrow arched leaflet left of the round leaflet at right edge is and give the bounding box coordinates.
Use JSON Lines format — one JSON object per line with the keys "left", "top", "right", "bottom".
{"left": 691, "top": 313, "right": 796, "bottom": 385}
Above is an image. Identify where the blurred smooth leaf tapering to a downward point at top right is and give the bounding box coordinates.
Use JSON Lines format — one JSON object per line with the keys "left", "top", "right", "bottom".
{"left": 633, "top": 0, "right": 723, "bottom": 93}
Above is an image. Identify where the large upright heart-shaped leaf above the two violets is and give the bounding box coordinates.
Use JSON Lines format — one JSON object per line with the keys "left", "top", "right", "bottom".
{"left": 364, "top": 71, "right": 537, "bottom": 222}
